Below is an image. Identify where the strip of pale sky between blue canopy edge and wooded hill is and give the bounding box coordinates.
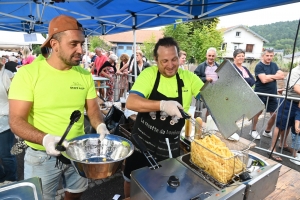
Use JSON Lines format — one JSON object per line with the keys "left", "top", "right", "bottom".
{"left": 218, "top": 3, "right": 300, "bottom": 28}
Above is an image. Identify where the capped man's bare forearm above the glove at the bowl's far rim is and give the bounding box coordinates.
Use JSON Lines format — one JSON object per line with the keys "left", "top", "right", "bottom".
{"left": 85, "top": 98, "right": 104, "bottom": 129}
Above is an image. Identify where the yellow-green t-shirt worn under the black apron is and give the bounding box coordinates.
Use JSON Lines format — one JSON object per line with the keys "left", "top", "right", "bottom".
{"left": 130, "top": 66, "right": 204, "bottom": 112}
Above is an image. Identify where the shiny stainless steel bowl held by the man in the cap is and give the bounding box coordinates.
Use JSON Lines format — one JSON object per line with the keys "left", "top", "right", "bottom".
{"left": 62, "top": 134, "right": 134, "bottom": 179}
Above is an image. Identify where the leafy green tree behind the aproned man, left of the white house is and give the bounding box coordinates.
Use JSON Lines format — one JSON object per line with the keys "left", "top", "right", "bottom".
{"left": 163, "top": 18, "right": 223, "bottom": 63}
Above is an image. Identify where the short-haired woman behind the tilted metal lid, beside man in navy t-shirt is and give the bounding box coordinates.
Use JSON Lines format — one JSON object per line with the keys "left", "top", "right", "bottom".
{"left": 233, "top": 49, "right": 255, "bottom": 87}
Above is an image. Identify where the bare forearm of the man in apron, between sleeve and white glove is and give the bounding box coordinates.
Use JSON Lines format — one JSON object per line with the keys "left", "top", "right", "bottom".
{"left": 126, "top": 94, "right": 160, "bottom": 112}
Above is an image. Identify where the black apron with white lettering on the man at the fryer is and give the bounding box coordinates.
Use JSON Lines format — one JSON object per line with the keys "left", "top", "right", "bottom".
{"left": 132, "top": 71, "right": 185, "bottom": 161}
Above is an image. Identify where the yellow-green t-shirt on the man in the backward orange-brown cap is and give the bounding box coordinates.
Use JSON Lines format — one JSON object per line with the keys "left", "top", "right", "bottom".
{"left": 9, "top": 60, "right": 96, "bottom": 150}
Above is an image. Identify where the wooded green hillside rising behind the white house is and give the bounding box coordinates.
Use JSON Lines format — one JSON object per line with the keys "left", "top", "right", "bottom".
{"left": 249, "top": 20, "right": 300, "bottom": 54}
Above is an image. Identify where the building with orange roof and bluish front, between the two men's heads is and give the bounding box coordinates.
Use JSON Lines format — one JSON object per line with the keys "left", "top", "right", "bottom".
{"left": 100, "top": 30, "right": 163, "bottom": 57}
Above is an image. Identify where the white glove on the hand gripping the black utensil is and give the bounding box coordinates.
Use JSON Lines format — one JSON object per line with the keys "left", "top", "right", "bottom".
{"left": 43, "top": 134, "right": 69, "bottom": 156}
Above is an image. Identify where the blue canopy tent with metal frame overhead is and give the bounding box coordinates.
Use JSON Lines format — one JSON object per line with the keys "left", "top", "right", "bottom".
{"left": 0, "top": 0, "right": 300, "bottom": 79}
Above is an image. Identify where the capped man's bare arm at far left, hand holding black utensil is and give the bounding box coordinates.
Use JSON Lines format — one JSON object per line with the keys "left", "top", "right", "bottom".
{"left": 9, "top": 100, "right": 45, "bottom": 144}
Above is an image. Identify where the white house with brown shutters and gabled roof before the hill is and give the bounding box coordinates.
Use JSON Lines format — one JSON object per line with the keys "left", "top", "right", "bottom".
{"left": 221, "top": 25, "right": 269, "bottom": 61}
